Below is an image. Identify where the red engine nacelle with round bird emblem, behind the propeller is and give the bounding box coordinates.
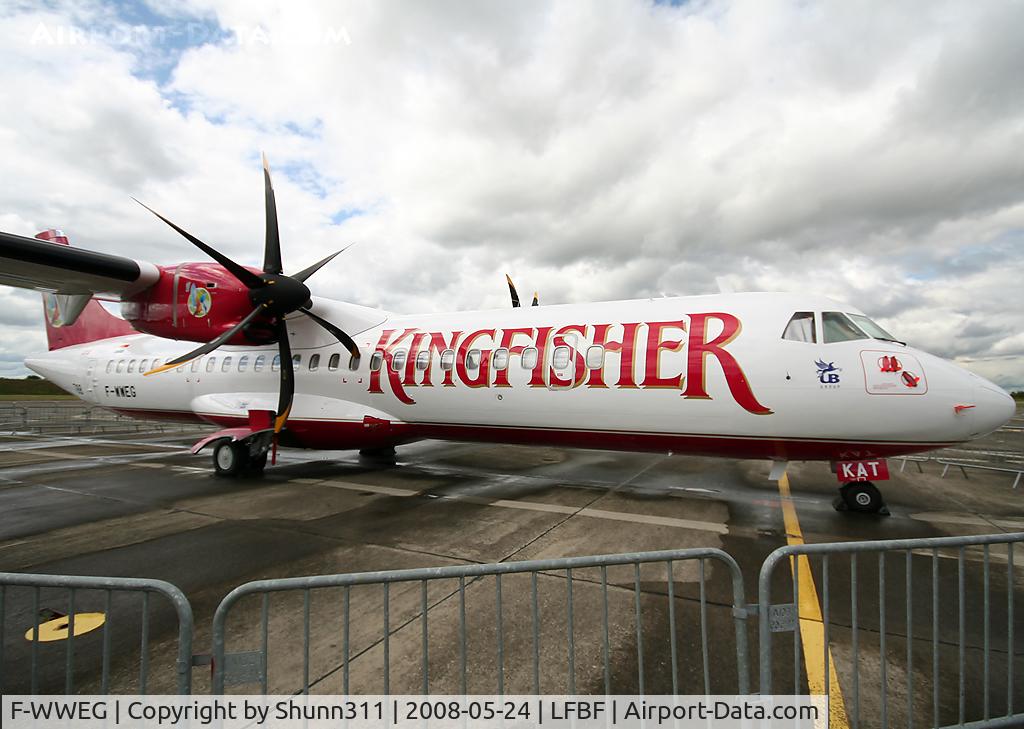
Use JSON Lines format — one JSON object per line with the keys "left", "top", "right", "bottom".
{"left": 121, "top": 262, "right": 273, "bottom": 344}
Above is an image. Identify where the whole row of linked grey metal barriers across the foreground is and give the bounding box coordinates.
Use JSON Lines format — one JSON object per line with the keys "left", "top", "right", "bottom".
{"left": 0, "top": 532, "right": 1024, "bottom": 729}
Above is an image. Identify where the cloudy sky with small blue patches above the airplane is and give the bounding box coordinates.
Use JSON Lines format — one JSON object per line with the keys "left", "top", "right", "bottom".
{"left": 0, "top": 0, "right": 1024, "bottom": 389}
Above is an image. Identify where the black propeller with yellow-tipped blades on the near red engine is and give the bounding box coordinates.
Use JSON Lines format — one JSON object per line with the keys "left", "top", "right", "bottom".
{"left": 140, "top": 155, "right": 359, "bottom": 436}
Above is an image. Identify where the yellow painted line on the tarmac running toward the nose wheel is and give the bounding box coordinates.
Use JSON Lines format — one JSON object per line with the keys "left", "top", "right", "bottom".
{"left": 778, "top": 473, "right": 850, "bottom": 729}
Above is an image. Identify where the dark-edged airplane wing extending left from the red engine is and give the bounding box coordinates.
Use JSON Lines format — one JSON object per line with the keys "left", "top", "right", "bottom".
{"left": 0, "top": 231, "right": 160, "bottom": 298}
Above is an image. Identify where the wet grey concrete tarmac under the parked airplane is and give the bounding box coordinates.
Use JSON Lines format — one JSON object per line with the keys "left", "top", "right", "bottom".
{"left": 0, "top": 401, "right": 1024, "bottom": 726}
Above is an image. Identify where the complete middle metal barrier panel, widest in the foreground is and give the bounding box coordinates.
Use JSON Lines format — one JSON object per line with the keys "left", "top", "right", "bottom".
{"left": 213, "top": 549, "right": 750, "bottom": 694}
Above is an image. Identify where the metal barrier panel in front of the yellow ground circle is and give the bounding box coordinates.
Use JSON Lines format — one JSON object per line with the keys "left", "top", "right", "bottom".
{"left": 0, "top": 572, "right": 193, "bottom": 694}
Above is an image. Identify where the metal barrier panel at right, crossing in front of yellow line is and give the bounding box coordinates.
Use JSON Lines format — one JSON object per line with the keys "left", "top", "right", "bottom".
{"left": 758, "top": 533, "right": 1024, "bottom": 727}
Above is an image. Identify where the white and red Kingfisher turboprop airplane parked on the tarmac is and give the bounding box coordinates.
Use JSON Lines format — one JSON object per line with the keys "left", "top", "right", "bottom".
{"left": 0, "top": 161, "right": 1014, "bottom": 511}
